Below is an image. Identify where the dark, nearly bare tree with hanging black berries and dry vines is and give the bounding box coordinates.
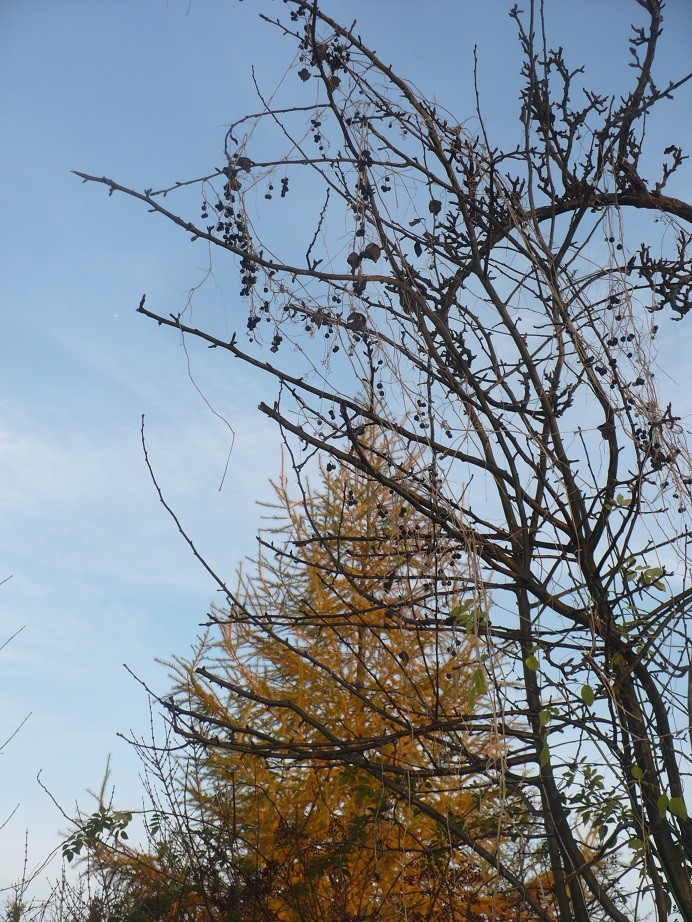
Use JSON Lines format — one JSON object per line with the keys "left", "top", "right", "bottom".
{"left": 78, "top": 0, "right": 692, "bottom": 922}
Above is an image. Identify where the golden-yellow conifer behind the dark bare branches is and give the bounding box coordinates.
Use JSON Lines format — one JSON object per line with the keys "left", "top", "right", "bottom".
{"left": 67, "top": 445, "right": 550, "bottom": 922}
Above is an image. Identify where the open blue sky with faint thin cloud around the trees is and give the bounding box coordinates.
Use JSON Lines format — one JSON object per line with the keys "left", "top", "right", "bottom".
{"left": 0, "top": 0, "right": 692, "bottom": 887}
